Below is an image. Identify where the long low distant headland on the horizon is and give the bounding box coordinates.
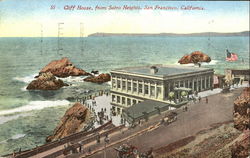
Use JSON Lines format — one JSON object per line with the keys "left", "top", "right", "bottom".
{"left": 88, "top": 31, "right": 249, "bottom": 37}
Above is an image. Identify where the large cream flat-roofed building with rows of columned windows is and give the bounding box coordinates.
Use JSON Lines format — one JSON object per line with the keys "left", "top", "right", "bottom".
{"left": 111, "top": 65, "right": 214, "bottom": 112}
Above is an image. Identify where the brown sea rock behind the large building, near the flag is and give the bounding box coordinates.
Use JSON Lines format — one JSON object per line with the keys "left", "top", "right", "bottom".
{"left": 178, "top": 51, "right": 211, "bottom": 64}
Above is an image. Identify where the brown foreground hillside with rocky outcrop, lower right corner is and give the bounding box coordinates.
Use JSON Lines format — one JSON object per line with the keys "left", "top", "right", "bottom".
{"left": 155, "top": 87, "right": 250, "bottom": 158}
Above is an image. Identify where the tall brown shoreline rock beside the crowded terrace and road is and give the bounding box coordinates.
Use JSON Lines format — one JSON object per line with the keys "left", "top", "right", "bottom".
{"left": 46, "top": 102, "right": 90, "bottom": 142}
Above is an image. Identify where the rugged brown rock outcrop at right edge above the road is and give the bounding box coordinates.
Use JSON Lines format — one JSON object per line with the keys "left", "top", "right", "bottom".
{"left": 234, "top": 87, "right": 250, "bottom": 131}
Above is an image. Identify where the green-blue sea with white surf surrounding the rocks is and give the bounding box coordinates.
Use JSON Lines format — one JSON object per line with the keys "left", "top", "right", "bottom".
{"left": 0, "top": 37, "right": 249, "bottom": 155}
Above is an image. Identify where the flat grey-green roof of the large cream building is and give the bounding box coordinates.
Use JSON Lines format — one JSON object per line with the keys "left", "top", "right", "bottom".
{"left": 113, "top": 65, "right": 213, "bottom": 77}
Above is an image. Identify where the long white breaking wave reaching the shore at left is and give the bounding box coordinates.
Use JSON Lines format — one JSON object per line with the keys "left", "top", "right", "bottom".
{"left": 0, "top": 100, "right": 70, "bottom": 116}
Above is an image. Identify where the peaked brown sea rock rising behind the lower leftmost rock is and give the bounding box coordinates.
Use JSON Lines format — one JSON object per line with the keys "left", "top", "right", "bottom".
{"left": 40, "top": 58, "right": 89, "bottom": 77}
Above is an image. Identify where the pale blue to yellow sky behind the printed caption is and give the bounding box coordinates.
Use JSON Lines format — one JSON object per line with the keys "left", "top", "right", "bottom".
{"left": 0, "top": 0, "right": 249, "bottom": 37}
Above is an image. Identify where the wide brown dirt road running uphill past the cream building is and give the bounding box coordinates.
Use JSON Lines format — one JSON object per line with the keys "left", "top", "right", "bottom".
{"left": 76, "top": 88, "right": 243, "bottom": 158}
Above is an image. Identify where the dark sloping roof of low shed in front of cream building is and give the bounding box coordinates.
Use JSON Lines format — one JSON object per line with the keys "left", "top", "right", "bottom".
{"left": 124, "top": 100, "right": 169, "bottom": 118}
